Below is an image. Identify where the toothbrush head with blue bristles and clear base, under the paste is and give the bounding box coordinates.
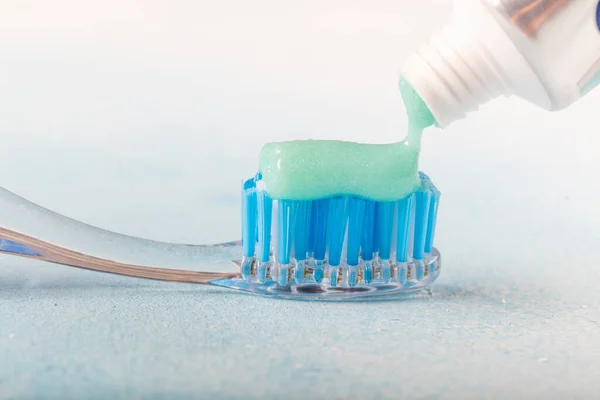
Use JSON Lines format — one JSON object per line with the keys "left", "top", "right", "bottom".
{"left": 211, "top": 173, "right": 441, "bottom": 300}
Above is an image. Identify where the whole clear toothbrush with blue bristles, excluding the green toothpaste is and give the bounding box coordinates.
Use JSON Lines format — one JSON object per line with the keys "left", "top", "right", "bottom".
{"left": 0, "top": 170, "right": 441, "bottom": 300}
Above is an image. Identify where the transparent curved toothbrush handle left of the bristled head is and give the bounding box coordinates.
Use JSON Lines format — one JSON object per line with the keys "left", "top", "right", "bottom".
{"left": 0, "top": 188, "right": 241, "bottom": 283}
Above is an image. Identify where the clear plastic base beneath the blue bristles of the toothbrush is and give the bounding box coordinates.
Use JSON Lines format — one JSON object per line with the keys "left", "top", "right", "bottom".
{"left": 212, "top": 249, "right": 441, "bottom": 300}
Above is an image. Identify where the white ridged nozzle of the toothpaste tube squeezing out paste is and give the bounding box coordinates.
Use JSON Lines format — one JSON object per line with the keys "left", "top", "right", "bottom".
{"left": 402, "top": 1, "right": 548, "bottom": 128}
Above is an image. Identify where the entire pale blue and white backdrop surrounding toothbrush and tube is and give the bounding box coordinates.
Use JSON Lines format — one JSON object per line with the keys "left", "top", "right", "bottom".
{"left": 0, "top": 0, "right": 600, "bottom": 399}
